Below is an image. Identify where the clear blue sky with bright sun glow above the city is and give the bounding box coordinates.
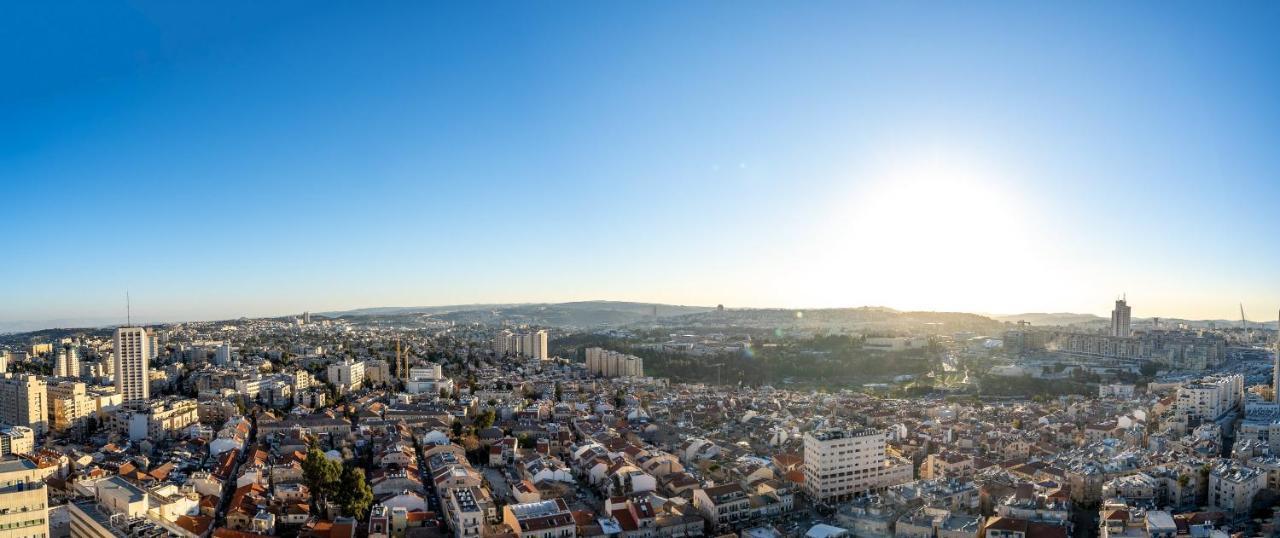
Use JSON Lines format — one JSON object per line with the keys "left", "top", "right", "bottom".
{"left": 0, "top": 1, "right": 1280, "bottom": 320}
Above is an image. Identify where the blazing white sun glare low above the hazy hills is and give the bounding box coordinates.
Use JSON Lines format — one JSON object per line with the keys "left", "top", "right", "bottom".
{"left": 803, "top": 151, "right": 1064, "bottom": 311}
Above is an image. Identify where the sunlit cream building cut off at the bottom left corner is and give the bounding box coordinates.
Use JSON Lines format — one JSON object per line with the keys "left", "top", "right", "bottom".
{"left": 0, "top": 457, "right": 50, "bottom": 538}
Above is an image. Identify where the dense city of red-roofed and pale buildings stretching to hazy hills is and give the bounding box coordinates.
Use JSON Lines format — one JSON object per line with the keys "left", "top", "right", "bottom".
{"left": 0, "top": 298, "right": 1280, "bottom": 538}
